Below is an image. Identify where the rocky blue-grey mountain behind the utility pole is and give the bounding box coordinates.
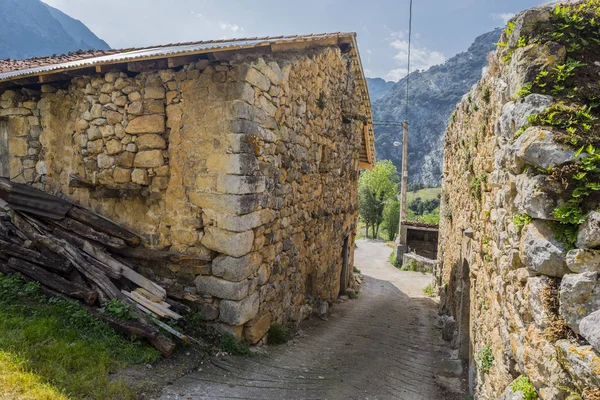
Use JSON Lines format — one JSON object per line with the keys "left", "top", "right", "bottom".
{"left": 373, "top": 29, "right": 502, "bottom": 186}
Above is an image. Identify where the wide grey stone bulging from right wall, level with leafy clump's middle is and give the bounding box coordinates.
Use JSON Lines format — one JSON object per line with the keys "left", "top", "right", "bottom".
{"left": 511, "top": 126, "right": 577, "bottom": 169}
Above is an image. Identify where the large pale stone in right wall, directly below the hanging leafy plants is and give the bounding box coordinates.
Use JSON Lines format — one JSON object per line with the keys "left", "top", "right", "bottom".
{"left": 520, "top": 220, "right": 569, "bottom": 277}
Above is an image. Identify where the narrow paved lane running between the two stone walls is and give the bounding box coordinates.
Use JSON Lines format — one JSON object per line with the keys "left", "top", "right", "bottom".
{"left": 161, "top": 240, "right": 466, "bottom": 400}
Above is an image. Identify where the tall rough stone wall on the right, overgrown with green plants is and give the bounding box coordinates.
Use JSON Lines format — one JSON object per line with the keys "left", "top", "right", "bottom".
{"left": 436, "top": 0, "right": 600, "bottom": 399}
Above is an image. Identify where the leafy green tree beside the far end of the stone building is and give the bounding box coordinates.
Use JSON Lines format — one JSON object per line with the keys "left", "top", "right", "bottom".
{"left": 358, "top": 160, "right": 398, "bottom": 239}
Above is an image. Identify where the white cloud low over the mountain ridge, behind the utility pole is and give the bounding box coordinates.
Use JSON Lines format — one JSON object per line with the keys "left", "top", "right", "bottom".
{"left": 385, "top": 32, "right": 446, "bottom": 81}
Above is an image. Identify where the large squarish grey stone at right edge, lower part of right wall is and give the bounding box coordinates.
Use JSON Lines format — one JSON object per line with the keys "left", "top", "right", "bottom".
{"left": 559, "top": 272, "right": 600, "bottom": 333}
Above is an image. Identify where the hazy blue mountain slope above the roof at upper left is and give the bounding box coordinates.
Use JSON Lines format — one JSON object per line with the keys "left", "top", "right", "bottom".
{"left": 0, "top": 0, "right": 110, "bottom": 59}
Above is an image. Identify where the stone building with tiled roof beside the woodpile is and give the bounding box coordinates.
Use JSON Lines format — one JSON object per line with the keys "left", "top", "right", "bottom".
{"left": 0, "top": 33, "right": 374, "bottom": 342}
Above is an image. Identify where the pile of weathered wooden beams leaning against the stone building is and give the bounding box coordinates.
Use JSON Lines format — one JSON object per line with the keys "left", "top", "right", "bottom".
{"left": 0, "top": 178, "right": 206, "bottom": 356}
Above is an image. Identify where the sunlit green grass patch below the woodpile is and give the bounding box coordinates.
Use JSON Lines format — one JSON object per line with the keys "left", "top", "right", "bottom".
{"left": 0, "top": 274, "right": 160, "bottom": 399}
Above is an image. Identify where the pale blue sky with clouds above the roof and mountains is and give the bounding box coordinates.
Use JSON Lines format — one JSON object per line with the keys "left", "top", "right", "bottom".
{"left": 43, "top": 0, "right": 546, "bottom": 81}
